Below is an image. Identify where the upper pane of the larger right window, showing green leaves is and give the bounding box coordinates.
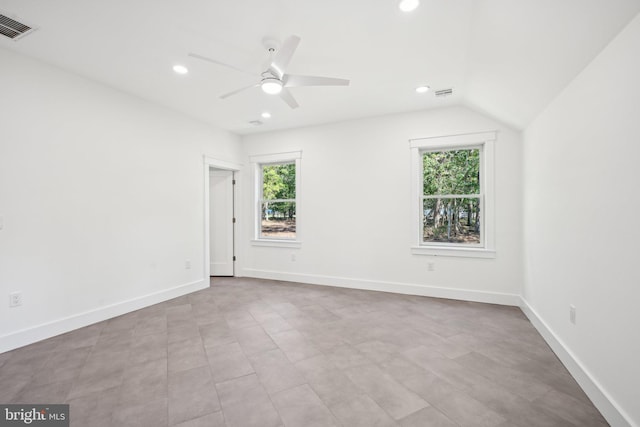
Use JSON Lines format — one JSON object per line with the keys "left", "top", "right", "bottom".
{"left": 422, "top": 148, "right": 480, "bottom": 196}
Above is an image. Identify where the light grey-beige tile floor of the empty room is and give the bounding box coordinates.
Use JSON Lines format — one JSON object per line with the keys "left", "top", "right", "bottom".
{"left": 0, "top": 278, "right": 607, "bottom": 427}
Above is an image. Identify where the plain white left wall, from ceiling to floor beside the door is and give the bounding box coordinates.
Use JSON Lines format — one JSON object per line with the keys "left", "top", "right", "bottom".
{"left": 0, "top": 49, "right": 239, "bottom": 351}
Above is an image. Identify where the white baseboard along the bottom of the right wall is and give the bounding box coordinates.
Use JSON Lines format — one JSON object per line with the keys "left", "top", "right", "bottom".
{"left": 520, "top": 297, "right": 638, "bottom": 427}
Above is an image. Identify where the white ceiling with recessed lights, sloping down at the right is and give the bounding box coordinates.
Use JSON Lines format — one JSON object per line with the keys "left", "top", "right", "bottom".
{"left": 0, "top": 0, "right": 640, "bottom": 134}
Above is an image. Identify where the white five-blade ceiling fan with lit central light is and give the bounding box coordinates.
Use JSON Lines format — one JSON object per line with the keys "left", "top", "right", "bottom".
{"left": 189, "top": 36, "right": 349, "bottom": 108}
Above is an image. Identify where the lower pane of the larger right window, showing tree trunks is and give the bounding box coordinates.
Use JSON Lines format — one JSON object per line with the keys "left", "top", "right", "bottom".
{"left": 422, "top": 197, "right": 481, "bottom": 245}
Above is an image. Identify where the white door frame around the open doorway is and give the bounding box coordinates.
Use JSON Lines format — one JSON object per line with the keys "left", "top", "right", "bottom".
{"left": 203, "top": 156, "right": 242, "bottom": 281}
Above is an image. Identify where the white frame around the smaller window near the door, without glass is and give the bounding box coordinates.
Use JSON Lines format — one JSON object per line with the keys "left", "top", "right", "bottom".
{"left": 249, "top": 151, "right": 302, "bottom": 248}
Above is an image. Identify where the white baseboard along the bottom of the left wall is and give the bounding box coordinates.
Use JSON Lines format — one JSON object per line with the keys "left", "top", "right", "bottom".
{"left": 0, "top": 279, "right": 209, "bottom": 353}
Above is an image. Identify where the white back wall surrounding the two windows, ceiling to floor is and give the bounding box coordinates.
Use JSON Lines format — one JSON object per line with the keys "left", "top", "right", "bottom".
{"left": 240, "top": 107, "right": 522, "bottom": 304}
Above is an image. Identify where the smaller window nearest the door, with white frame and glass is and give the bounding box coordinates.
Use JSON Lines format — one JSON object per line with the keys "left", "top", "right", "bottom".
{"left": 251, "top": 152, "right": 301, "bottom": 247}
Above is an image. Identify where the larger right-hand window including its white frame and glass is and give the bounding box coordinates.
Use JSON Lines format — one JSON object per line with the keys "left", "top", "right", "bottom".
{"left": 411, "top": 132, "right": 495, "bottom": 257}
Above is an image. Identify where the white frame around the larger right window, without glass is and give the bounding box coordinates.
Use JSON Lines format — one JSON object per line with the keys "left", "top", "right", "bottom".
{"left": 409, "top": 131, "right": 496, "bottom": 258}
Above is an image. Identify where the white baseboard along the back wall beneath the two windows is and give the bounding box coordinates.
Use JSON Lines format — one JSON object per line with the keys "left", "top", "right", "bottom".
{"left": 242, "top": 268, "right": 520, "bottom": 307}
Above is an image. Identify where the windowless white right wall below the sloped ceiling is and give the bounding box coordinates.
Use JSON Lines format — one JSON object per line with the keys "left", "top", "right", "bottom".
{"left": 524, "top": 13, "right": 640, "bottom": 425}
